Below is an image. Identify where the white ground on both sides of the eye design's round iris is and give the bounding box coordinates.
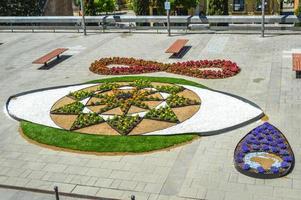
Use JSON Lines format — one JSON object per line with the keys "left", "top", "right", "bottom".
{"left": 8, "top": 84, "right": 263, "bottom": 135}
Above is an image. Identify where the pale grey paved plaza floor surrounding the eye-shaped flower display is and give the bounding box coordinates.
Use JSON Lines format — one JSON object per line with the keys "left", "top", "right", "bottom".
{"left": 0, "top": 32, "right": 301, "bottom": 200}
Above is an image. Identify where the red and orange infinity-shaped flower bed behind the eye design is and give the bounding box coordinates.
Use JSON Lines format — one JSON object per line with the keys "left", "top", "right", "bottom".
{"left": 90, "top": 57, "right": 240, "bottom": 79}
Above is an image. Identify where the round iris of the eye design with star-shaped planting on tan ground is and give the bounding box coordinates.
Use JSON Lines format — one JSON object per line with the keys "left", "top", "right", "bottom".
{"left": 50, "top": 80, "right": 201, "bottom": 135}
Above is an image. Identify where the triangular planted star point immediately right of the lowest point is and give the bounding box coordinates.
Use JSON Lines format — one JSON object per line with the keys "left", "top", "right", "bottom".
{"left": 145, "top": 107, "right": 179, "bottom": 123}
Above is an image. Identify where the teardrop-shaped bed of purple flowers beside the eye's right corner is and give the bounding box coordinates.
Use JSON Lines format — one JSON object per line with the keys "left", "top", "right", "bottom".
{"left": 234, "top": 122, "right": 295, "bottom": 179}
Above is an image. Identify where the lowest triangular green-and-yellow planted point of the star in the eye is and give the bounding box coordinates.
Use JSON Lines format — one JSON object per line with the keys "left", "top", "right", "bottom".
{"left": 107, "top": 115, "right": 141, "bottom": 135}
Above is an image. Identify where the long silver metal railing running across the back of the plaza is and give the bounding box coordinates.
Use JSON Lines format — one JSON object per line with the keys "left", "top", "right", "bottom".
{"left": 0, "top": 15, "right": 301, "bottom": 30}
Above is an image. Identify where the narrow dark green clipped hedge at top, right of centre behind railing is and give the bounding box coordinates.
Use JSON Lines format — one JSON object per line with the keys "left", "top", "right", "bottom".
{"left": 207, "top": 0, "right": 228, "bottom": 15}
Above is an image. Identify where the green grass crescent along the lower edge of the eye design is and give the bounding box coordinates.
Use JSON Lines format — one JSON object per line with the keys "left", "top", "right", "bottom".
{"left": 21, "top": 121, "right": 198, "bottom": 153}
